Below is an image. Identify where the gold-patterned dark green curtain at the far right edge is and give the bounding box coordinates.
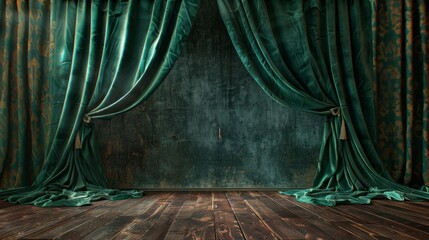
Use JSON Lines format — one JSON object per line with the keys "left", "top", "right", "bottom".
{"left": 374, "top": 0, "right": 429, "bottom": 190}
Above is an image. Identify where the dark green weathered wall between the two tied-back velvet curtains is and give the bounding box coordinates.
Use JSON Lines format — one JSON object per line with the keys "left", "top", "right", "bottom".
{"left": 96, "top": 0, "right": 324, "bottom": 188}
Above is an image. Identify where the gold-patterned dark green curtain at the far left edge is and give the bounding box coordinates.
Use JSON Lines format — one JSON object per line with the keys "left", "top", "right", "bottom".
{"left": 0, "top": 0, "right": 50, "bottom": 188}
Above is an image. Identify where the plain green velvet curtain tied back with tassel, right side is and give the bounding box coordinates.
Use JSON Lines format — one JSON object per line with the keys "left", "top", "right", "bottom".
{"left": 218, "top": 0, "right": 429, "bottom": 206}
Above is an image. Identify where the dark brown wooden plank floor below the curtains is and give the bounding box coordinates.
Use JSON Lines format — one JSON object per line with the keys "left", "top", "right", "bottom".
{"left": 0, "top": 191, "right": 429, "bottom": 240}
